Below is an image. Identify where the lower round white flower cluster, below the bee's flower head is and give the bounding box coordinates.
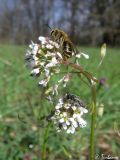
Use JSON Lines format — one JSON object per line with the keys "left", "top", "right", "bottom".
{"left": 51, "top": 94, "right": 88, "bottom": 134}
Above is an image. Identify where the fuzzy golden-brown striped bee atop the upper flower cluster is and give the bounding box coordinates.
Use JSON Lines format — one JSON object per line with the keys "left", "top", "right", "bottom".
{"left": 50, "top": 29, "right": 77, "bottom": 60}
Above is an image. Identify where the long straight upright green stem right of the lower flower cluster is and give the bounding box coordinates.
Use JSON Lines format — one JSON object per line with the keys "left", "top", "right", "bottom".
{"left": 90, "top": 84, "right": 96, "bottom": 160}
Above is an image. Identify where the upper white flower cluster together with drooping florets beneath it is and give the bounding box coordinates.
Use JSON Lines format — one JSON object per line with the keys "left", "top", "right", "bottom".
{"left": 25, "top": 36, "right": 76, "bottom": 99}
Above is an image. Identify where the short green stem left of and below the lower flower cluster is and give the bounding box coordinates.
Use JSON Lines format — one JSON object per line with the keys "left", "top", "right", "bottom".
{"left": 42, "top": 123, "right": 51, "bottom": 160}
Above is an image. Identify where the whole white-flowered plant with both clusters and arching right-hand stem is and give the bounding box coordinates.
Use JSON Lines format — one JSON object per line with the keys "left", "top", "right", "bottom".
{"left": 25, "top": 36, "right": 101, "bottom": 160}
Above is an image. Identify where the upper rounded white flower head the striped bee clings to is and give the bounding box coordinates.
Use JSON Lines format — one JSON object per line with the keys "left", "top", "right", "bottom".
{"left": 25, "top": 36, "right": 62, "bottom": 87}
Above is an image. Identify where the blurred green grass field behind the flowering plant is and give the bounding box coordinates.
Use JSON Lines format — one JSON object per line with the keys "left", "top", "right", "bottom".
{"left": 0, "top": 45, "right": 120, "bottom": 160}
